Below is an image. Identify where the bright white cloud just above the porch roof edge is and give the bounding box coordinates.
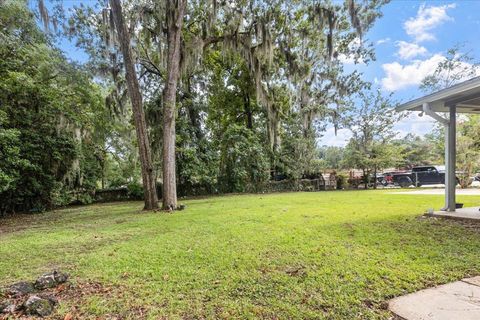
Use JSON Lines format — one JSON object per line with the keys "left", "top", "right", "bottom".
{"left": 382, "top": 54, "right": 445, "bottom": 91}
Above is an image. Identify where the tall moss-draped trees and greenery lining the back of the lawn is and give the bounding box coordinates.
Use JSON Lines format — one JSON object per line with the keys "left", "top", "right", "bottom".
{"left": 0, "top": 0, "right": 476, "bottom": 212}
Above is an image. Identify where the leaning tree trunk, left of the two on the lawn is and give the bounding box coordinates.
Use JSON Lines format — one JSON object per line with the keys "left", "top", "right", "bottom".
{"left": 110, "top": 0, "right": 158, "bottom": 210}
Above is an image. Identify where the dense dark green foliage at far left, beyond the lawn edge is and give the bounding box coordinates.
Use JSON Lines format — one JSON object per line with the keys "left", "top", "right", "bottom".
{"left": 0, "top": 1, "right": 103, "bottom": 213}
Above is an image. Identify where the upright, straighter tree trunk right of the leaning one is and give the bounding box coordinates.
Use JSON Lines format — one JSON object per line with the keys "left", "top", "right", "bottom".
{"left": 162, "top": 0, "right": 185, "bottom": 210}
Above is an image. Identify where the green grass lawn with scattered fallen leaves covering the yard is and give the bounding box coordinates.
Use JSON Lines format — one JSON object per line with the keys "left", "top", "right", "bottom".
{"left": 0, "top": 191, "right": 480, "bottom": 319}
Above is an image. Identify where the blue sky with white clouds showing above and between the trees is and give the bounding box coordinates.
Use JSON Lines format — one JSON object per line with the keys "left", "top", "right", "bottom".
{"left": 42, "top": 0, "right": 480, "bottom": 146}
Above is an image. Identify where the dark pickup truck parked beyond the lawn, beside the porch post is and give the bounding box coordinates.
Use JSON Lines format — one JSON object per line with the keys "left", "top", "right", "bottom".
{"left": 393, "top": 166, "right": 452, "bottom": 188}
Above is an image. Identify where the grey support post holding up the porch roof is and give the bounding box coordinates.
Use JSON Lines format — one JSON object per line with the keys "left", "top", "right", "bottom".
{"left": 445, "top": 106, "right": 457, "bottom": 212}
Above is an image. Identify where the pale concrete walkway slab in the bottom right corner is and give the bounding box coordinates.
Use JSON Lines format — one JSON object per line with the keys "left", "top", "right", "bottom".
{"left": 388, "top": 277, "right": 480, "bottom": 320}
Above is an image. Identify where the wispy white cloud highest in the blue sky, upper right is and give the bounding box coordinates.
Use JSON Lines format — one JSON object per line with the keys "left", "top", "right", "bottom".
{"left": 403, "top": 3, "right": 455, "bottom": 42}
